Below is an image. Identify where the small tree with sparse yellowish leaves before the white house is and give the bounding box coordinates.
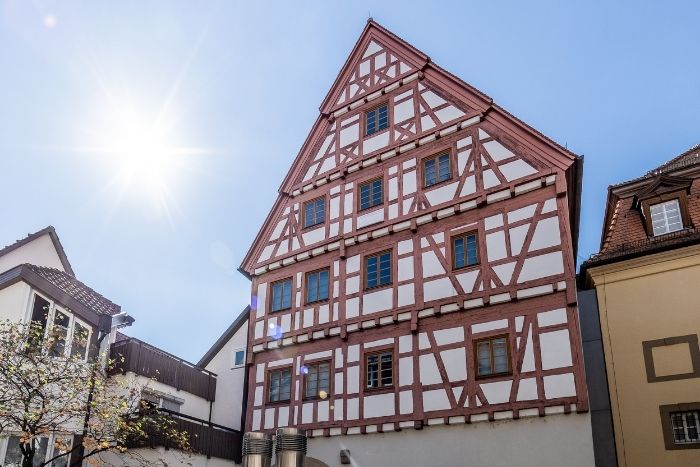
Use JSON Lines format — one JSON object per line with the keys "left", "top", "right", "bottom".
{"left": 0, "top": 320, "right": 189, "bottom": 467}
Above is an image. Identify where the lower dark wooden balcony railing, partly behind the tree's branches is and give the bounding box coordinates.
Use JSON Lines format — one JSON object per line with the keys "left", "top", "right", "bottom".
{"left": 130, "top": 409, "right": 243, "bottom": 464}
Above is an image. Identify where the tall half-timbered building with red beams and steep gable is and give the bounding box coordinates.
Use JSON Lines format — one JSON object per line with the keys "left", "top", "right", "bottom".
{"left": 241, "top": 20, "right": 593, "bottom": 466}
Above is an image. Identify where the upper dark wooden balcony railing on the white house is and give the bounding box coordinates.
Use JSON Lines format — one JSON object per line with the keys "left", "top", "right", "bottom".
{"left": 110, "top": 338, "right": 216, "bottom": 401}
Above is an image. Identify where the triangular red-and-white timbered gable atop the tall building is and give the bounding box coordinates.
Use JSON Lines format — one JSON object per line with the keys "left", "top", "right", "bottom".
{"left": 241, "top": 21, "right": 580, "bottom": 275}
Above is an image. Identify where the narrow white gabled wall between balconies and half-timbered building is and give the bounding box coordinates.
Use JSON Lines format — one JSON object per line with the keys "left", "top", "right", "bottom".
{"left": 204, "top": 321, "right": 248, "bottom": 430}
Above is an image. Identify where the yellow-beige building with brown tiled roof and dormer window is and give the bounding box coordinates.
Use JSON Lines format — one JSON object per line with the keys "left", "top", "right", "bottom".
{"left": 580, "top": 146, "right": 700, "bottom": 467}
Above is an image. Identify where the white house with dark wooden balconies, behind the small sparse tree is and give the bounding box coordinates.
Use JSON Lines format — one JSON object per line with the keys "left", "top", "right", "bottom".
{"left": 0, "top": 227, "right": 247, "bottom": 467}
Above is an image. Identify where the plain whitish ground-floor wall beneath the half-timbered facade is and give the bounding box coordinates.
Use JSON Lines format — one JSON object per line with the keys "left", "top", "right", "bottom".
{"left": 308, "top": 414, "right": 594, "bottom": 467}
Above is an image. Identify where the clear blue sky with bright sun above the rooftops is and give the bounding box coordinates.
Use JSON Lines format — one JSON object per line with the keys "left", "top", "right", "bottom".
{"left": 0, "top": 0, "right": 700, "bottom": 361}
